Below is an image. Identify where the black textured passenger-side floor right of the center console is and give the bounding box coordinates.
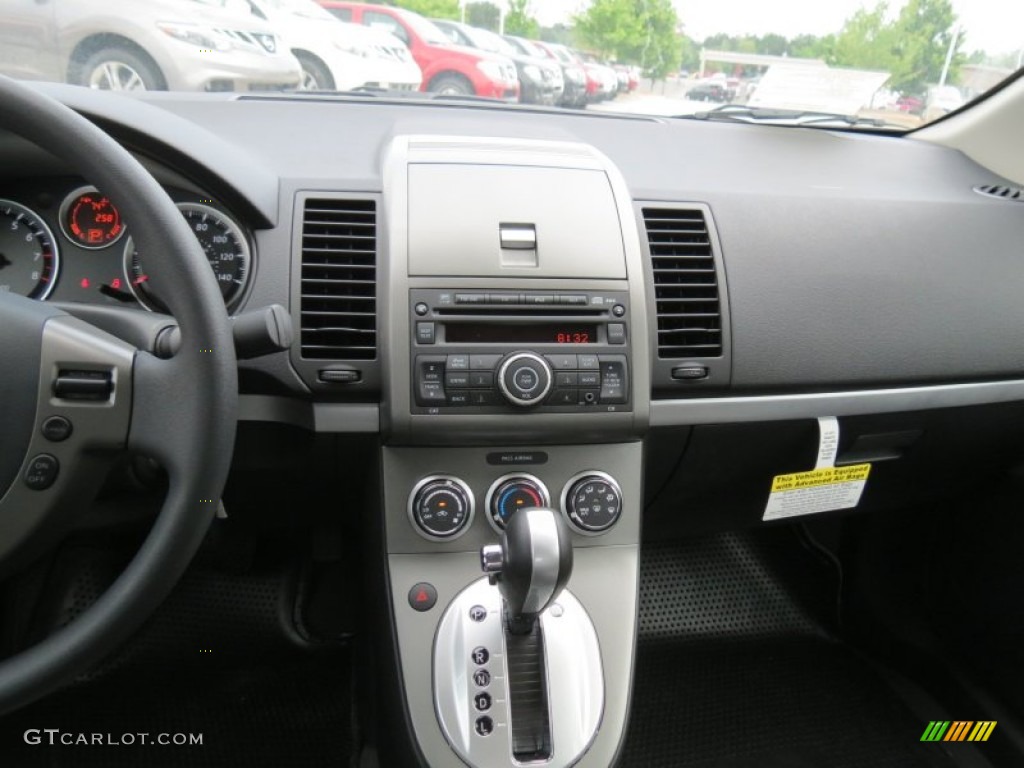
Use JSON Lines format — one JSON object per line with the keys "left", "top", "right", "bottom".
{"left": 622, "top": 528, "right": 986, "bottom": 768}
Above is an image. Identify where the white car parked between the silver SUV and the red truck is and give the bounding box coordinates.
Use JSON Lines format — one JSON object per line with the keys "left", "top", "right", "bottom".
{"left": 247, "top": 0, "right": 423, "bottom": 90}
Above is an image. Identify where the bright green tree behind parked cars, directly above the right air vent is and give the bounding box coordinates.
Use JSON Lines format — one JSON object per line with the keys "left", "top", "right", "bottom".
{"left": 574, "top": 0, "right": 682, "bottom": 78}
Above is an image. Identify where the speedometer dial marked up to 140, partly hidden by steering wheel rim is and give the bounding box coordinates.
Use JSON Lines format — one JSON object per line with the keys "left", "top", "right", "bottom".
{"left": 125, "top": 203, "right": 250, "bottom": 312}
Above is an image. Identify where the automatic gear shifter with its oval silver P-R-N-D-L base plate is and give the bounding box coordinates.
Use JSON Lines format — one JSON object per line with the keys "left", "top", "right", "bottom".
{"left": 433, "top": 507, "right": 604, "bottom": 768}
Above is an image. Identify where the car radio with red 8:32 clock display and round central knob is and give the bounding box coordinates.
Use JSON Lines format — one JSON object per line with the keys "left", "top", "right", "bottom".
{"left": 410, "top": 289, "right": 632, "bottom": 414}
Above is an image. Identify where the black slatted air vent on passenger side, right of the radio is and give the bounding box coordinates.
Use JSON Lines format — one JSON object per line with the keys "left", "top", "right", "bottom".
{"left": 643, "top": 208, "right": 722, "bottom": 358}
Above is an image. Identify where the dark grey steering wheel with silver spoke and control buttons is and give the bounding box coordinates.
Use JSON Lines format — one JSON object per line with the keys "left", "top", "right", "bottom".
{"left": 0, "top": 77, "right": 238, "bottom": 714}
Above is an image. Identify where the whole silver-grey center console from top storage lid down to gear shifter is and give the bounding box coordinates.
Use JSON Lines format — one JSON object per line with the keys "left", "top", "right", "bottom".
{"left": 381, "top": 135, "right": 650, "bottom": 768}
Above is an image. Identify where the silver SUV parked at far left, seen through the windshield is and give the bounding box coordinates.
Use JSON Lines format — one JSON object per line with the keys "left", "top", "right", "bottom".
{"left": 0, "top": 0, "right": 302, "bottom": 91}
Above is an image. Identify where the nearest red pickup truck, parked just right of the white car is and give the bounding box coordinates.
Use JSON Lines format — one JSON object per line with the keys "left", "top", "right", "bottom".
{"left": 319, "top": 0, "right": 519, "bottom": 101}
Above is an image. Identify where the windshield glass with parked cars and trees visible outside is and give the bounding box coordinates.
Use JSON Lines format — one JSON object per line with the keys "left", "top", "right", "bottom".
{"left": 0, "top": 0, "right": 1024, "bottom": 129}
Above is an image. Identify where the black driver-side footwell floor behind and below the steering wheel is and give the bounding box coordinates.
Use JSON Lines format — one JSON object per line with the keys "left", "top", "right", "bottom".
{"left": 0, "top": 545, "right": 355, "bottom": 768}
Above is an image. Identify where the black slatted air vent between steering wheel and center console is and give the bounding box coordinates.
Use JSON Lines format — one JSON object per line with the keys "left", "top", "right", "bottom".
{"left": 300, "top": 199, "right": 377, "bottom": 360}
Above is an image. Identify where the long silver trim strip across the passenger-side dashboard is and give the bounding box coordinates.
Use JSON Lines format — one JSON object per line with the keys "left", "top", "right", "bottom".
{"left": 650, "top": 379, "right": 1024, "bottom": 427}
